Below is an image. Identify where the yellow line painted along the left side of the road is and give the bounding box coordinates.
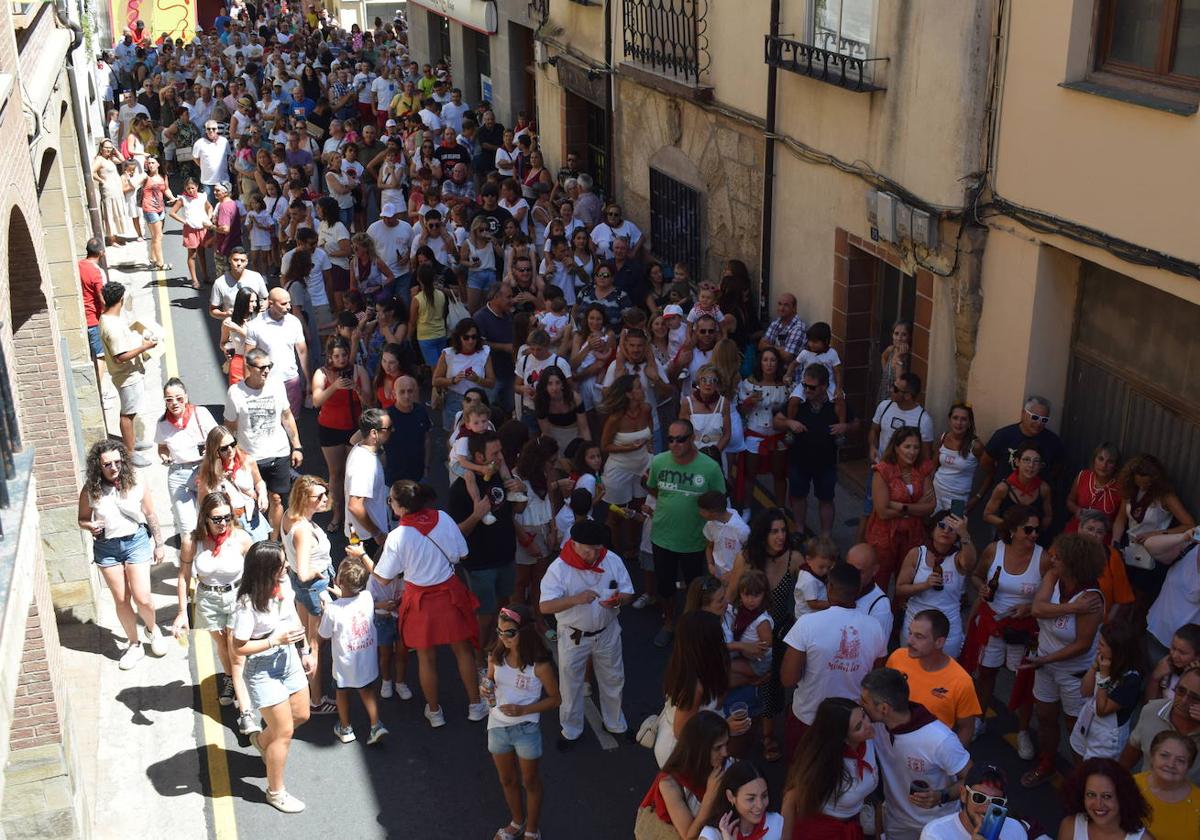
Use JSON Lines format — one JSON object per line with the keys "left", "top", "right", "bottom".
{"left": 154, "top": 271, "right": 238, "bottom": 840}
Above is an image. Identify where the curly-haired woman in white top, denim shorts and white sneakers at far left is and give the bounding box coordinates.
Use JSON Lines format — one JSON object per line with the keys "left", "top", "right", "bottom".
{"left": 77, "top": 439, "right": 167, "bottom": 671}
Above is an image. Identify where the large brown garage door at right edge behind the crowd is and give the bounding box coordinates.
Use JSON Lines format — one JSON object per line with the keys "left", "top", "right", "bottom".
{"left": 1063, "top": 264, "right": 1200, "bottom": 514}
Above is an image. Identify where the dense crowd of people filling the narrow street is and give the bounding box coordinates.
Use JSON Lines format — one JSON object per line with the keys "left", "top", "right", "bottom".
{"left": 79, "top": 0, "right": 1200, "bottom": 840}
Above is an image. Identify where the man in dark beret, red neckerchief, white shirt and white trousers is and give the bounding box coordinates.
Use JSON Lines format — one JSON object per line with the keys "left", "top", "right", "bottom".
{"left": 538, "top": 520, "right": 634, "bottom": 751}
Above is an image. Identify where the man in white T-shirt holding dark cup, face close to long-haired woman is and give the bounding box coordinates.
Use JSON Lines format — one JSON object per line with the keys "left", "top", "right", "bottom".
{"left": 864, "top": 667, "right": 971, "bottom": 840}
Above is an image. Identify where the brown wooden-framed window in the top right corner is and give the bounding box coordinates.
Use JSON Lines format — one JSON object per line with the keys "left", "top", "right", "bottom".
{"left": 1096, "top": 0, "right": 1200, "bottom": 89}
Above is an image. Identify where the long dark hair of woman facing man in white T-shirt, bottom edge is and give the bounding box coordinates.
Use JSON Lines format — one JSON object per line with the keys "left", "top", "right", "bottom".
{"left": 784, "top": 697, "right": 858, "bottom": 818}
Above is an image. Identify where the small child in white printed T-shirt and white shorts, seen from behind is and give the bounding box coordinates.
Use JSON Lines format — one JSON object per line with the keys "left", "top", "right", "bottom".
{"left": 317, "top": 554, "right": 388, "bottom": 744}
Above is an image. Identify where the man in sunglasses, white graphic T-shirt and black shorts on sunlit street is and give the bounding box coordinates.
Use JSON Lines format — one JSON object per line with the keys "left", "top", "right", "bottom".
{"left": 224, "top": 347, "right": 304, "bottom": 528}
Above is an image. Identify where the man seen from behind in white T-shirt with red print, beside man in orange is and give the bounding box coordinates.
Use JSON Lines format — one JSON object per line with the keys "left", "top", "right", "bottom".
{"left": 780, "top": 563, "right": 890, "bottom": 758}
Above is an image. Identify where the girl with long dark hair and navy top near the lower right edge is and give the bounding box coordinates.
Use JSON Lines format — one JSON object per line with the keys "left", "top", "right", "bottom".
{"left": 1070, "top": 622, "right": 1142, "bottom": 761}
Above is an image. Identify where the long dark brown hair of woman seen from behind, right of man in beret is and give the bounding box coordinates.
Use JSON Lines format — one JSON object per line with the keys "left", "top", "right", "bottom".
{"left": 662, "top": 610, "right": 730, "bottom": 709}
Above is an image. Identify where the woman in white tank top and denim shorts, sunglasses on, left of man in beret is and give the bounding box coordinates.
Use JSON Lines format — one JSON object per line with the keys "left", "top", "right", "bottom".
{"left": 485, "top": 604, "right": 560, "bottom": 840}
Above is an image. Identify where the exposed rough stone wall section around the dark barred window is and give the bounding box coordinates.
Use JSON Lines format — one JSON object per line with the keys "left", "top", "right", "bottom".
{"left": 614, "top": 77, "right": 764, "bottom": 289}
